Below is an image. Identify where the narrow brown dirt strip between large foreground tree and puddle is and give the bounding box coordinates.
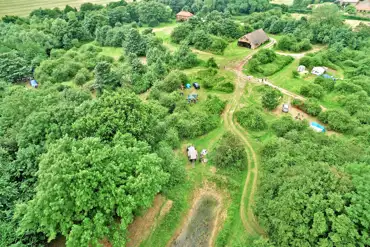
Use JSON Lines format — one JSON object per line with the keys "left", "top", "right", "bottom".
{"left": 126, "top": 194, "right": 172, "bottom": 247}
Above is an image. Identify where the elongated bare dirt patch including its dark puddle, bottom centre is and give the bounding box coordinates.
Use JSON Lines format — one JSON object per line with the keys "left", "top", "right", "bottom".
{"left": 167, "top": 182, "right": 226, "bottom": 247}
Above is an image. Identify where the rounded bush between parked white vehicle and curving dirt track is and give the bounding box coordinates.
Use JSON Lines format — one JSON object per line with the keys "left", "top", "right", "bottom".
{"left": 212, "top": 132, "right": 247, "bottom": 170}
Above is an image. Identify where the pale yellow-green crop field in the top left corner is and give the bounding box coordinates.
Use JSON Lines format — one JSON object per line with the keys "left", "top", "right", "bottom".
{"left": 0, "top": 0, "right": 117, "bottom": 17}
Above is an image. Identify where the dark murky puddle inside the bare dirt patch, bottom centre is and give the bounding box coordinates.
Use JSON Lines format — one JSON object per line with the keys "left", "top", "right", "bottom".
{"left": 170, "top": 195, "right": 219, "bottom": 247}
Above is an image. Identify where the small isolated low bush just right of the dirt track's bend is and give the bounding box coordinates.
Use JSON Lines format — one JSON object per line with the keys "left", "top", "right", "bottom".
{"left": 235, "top": 107, "right": 267, "bottom": 130}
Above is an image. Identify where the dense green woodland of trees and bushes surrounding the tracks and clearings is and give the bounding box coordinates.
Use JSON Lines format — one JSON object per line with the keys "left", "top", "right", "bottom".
{"left": 0, "top": 0, "right": 370, "bottom": 247}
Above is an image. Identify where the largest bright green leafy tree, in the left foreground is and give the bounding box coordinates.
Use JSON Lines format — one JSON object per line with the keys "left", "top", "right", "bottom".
{"left": 18, "top": 134, "right": 168, "bottom": 246}
